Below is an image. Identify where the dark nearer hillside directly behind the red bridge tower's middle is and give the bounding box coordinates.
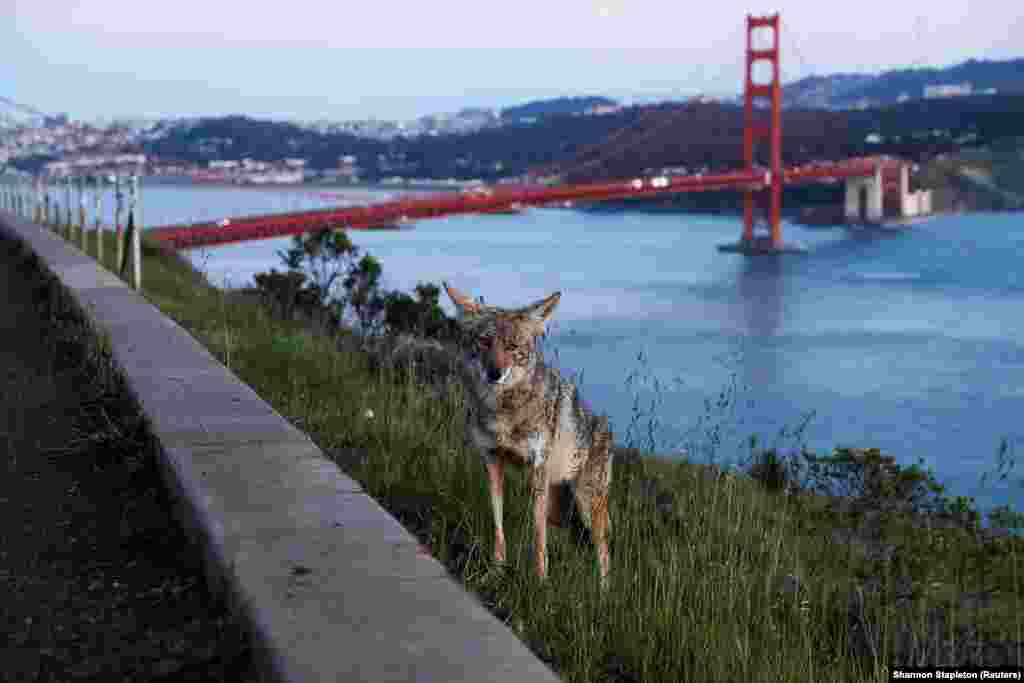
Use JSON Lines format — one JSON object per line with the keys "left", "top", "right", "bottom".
{"left": 545, "top": 95, "right": 1024, "bottom": 181}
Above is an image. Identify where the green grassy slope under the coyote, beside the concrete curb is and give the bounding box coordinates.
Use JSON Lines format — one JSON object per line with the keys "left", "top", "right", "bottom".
{"left": 29, "top": 218, "right": 1024, "bottom": 683}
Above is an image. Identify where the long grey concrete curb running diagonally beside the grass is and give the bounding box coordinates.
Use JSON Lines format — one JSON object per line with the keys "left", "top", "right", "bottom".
{"left": 0, "top": 212, "right": 558, "bottom": 683}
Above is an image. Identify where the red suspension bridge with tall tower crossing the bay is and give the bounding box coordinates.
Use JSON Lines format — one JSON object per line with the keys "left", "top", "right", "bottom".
{"left": 146, "top": 14, "right": 906, "bottom": 253}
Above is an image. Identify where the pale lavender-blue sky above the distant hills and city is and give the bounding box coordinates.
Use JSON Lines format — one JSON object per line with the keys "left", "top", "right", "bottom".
{"left": 0, "top": 0, "right": 1024, "bottom": 121}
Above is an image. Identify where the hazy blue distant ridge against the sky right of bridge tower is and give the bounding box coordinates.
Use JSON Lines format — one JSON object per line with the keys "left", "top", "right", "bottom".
{"left": 782, "top": 58, "right": 1024, "bottom": 109}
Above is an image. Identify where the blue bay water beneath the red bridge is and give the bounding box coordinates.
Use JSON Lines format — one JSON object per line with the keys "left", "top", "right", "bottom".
{"left": 41, "top": 185, "right": 1024, "bottom": 524}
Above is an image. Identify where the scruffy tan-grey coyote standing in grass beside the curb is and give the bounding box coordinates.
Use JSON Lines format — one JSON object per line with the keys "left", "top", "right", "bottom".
{"left": 444, "top": 283, "right": 612, "bottom": 588}
